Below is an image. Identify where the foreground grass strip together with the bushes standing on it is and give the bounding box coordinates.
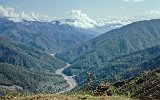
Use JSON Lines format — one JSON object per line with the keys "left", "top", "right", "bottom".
{"left": 1, "top": 74, "right": 129, "bottom": 100}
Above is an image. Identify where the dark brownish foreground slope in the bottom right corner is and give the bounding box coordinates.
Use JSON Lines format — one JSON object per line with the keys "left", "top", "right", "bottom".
{"left": 115, "top": 70, "right": 160, "bottom": 100}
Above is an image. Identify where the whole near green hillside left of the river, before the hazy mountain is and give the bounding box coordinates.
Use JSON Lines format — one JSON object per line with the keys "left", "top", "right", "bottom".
{"left": 0, "top": 37, "right": 68, "bottom": 95}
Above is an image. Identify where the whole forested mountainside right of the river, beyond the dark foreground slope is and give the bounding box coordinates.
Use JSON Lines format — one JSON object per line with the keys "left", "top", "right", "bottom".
{"left": 56, "top": 19, "right": 160, "bottom": 83}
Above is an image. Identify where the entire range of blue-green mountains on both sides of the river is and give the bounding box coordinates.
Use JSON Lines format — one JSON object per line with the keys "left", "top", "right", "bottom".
{"left": 0, "top": 17, "right": 160, "bottom": 99}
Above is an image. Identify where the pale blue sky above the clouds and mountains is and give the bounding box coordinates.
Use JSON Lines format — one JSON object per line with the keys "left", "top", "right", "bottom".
{"left": 0, "top": 0, "right": 160, "bottom": 18}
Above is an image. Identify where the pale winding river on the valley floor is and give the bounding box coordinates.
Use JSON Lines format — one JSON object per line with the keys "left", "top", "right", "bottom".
{"left": 51, "top": 54, "right": 77, "bottom": 94}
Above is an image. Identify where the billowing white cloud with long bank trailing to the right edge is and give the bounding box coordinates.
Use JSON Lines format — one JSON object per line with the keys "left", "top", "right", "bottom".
{"left": 61, "top": 10, "right": 160, "bottom": 29}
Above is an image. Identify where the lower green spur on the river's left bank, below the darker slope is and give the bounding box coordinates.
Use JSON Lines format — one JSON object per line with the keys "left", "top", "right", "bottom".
{"left": 0, "top": 63, "right": 68, "bottom": 96}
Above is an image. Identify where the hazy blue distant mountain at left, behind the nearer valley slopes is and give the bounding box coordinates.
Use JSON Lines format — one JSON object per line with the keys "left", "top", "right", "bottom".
{"left": 0, "top": 18, "right": 96, "bottom": 53}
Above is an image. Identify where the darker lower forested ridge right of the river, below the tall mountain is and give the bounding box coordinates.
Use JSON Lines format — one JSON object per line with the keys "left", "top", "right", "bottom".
{"left": 64, "top": 45, "right": 160, "bottom": 84}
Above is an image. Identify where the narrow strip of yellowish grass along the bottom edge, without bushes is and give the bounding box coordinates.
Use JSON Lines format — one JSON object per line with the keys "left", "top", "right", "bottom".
{"left": 3, "top": 94, "right": 130, "bottom": 100}
